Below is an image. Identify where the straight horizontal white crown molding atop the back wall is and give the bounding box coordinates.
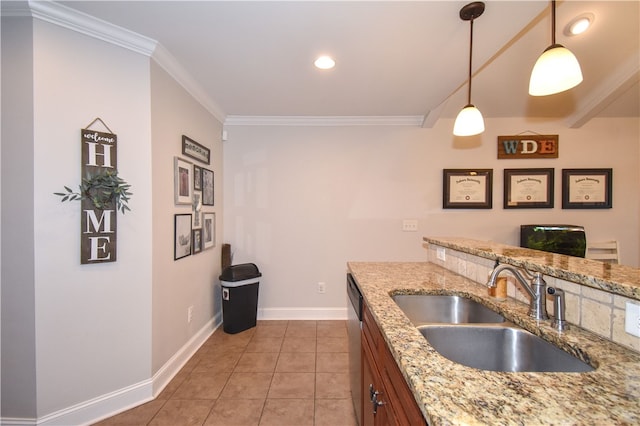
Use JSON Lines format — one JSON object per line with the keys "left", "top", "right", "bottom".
{"left": 224, "top": 115, "right": 424, "bottom": 127}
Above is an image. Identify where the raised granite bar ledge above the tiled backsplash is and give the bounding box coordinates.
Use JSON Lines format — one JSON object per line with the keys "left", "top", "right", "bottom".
{"left": 424, "top": 237, "right": 640, "bottom": 300}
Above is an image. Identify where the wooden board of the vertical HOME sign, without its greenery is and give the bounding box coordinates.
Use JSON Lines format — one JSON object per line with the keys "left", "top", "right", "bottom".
{"left": 80, "top": 118, "right": 118, "bottom": 264}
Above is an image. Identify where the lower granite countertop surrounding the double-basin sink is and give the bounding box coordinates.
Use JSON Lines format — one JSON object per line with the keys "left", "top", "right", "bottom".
{"left": 348, "top": 262, "right": 640, "bottom": 425}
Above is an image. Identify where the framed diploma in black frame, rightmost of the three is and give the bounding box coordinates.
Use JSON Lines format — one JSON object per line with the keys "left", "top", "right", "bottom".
{"left": 562, "top": 169, "right": 613, "bottom": 209}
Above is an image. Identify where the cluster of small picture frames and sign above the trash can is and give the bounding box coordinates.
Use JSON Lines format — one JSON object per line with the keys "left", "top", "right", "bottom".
{"left": 173, "top": 135, "right": 216, "bottom": 260}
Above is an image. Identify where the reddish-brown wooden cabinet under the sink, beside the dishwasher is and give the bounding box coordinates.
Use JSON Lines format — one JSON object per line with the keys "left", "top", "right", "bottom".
{"left": 362, "top": 304, "right": 426, "bottom": 426}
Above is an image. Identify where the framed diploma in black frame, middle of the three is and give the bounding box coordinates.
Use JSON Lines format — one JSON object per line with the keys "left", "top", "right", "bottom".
{"left": 504, "top": 169, "right": 554, "bottom": 209}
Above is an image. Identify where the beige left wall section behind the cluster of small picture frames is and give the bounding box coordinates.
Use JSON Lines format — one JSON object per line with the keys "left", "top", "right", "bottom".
{"left": 151, "top": 62, "right": 223, "bottom": 374}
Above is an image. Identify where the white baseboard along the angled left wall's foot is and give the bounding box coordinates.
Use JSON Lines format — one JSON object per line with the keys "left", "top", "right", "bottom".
{"left": 0, "top": 312, "right": 222, "bottom": 426}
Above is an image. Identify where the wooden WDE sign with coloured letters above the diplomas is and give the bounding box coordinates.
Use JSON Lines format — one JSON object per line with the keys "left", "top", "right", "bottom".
{"left": 498, "top": 135, "right": 558, "bottom": 159}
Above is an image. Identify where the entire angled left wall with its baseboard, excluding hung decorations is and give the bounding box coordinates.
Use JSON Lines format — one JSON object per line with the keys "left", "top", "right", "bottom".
{"left": 0, "top": 10, "right": 223, "bottom": 424}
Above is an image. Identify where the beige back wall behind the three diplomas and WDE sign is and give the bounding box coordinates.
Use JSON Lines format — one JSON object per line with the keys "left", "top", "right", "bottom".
{"left": 224, "top": 119, "right": 640, "bottom": 318}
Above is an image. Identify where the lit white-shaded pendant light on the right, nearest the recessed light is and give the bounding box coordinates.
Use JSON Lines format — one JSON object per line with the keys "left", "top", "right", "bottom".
{"left": 529, "top": 0, "right": 582, "bottom": 96}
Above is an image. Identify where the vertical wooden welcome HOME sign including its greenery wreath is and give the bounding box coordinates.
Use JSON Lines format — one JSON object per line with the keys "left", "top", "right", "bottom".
{"left": 55, "top": 118, "right": 131, "bottom": 264}
